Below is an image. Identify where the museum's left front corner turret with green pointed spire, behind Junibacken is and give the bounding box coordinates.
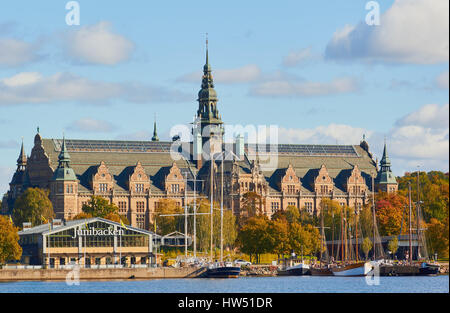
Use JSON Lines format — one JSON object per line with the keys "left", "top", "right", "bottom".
{"left": 50, "top": 137, "right": 79, "bottom": 219}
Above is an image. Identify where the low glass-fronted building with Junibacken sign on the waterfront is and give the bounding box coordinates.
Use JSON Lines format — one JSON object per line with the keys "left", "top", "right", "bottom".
{"left": 19, "top": 217, "right": 161, "bottom": 268}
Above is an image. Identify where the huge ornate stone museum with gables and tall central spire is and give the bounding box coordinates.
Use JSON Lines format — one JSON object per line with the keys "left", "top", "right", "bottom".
{"left": 2, "top": 45, "right": 397, "bottom": 229}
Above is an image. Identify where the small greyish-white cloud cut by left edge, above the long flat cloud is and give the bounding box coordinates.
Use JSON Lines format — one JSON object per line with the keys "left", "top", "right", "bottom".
{"left": 0, "top": 38, "right": 39, "bottom": 67}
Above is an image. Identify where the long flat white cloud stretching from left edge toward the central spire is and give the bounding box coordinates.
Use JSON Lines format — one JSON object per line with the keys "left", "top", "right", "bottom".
{"left": 0, "top": 72, "right": 191, "bottom": 106}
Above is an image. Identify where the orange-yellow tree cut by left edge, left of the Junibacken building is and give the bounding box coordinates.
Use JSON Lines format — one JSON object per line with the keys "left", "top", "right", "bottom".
{"left": 0, "top": 215, "right": 22, "bottom": 265}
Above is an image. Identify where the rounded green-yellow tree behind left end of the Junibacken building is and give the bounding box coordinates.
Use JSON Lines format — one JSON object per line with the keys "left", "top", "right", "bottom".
{"left": 12, "top": 188, "right": 55, "bottom": 227}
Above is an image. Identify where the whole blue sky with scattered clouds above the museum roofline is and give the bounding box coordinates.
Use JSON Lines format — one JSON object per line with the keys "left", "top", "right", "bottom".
{"left": 0, "top": 0, "right": 449, "bottom": 193}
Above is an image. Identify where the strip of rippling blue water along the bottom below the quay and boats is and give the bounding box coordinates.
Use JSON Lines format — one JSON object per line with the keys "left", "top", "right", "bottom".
{"left": 0, "top": 275, "right": 449, "bottom": 293}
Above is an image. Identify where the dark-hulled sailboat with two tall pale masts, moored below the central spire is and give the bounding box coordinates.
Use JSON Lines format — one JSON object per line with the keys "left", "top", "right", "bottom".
{"left": 206, "top": 154, "right": 241, "bottom": 278}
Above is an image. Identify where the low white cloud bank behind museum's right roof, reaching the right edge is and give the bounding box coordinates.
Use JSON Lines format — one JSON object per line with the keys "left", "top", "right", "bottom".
{"left": 258, "top": 105, "right": 449, "bottom": 175}
